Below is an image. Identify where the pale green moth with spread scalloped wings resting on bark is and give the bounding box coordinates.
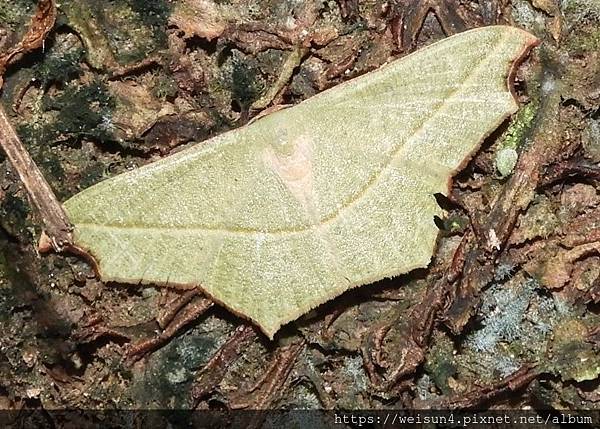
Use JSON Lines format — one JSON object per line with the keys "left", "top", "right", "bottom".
{"left": 59, "top": 26, "right": 537, "bottom": 338}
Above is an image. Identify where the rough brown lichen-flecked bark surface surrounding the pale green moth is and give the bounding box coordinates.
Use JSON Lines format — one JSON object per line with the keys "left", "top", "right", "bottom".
{"left": 0, "top": 0, "right": 600, "bottom": 416}
